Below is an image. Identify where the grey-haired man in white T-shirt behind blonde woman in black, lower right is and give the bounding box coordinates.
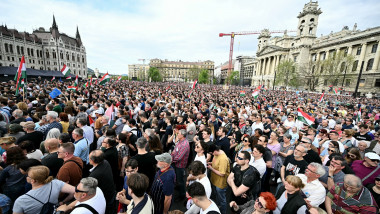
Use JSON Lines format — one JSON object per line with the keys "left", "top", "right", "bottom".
{"left": 296, "top": 162, "right": 326, "bottom": 207}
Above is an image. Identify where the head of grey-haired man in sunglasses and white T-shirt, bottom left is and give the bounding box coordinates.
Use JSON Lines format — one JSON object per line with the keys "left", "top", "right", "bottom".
{"left": 74, "top": 177, "right": 98, "bottom": 202}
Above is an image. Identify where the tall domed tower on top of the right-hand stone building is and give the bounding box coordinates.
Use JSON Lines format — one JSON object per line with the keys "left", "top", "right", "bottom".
{"left": 297, "top": 1, "right": 322, "bottom": 38}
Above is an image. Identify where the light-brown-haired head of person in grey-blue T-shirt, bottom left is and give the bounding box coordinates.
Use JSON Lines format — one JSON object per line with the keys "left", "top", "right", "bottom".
{"left": 26, "top": 166, "right": 53, "bottom": 186}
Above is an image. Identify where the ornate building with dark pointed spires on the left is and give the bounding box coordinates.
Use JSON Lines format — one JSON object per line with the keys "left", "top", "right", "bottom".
{"left": 0, "top": 16, "right": 87, "bottom": 77}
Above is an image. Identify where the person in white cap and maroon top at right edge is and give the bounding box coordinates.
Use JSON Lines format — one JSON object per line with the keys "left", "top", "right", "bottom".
{"left": 351, "top": 152, "right": 380, "bottom": 186}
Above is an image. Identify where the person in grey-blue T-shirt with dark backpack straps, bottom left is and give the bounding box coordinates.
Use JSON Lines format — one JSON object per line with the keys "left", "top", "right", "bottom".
{"left": 13, "top": 166, "right": 75, "bottom": 214}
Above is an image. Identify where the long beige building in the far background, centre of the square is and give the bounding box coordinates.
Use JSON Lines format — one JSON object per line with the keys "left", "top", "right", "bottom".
{"left": 149, "top": 59, "right": 214, "bottom": 83}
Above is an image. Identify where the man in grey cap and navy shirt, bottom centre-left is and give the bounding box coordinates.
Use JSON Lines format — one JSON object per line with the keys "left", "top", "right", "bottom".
{"left": 150, "top": 153, "right": 176, "bottom": 214}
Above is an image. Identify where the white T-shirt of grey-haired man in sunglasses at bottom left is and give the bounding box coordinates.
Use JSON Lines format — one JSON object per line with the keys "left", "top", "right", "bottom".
{"left": 71, "top": 187, "right": 106, "bottom": 214}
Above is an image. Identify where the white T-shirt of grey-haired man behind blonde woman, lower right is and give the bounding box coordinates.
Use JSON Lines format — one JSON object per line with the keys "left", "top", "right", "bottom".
{"left": 296, "top": 174, "right": 326, "bottom": 207}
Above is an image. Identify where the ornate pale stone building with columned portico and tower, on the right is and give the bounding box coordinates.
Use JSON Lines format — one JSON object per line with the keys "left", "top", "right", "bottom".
{"left": 252, "top": 1, "right": 380, "bottom": 93}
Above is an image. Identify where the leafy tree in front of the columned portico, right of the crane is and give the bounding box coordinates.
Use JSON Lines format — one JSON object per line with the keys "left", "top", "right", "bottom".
{"left": 274, "top": 60, "right": 300, "bottom": 87}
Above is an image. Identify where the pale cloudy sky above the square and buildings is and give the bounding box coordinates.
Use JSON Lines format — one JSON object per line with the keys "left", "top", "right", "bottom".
{"left": 0, "top": 0, "right": 380, "bottom": 75}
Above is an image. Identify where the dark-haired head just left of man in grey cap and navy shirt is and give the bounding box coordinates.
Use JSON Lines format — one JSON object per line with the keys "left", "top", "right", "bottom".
{"left": 127, "top": 173, "right": 149, "bottom": 198}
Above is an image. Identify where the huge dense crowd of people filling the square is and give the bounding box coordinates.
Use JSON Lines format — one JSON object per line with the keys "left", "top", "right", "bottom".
{"left": 0, "top": 78, "right": 380, "bottom": 214}
